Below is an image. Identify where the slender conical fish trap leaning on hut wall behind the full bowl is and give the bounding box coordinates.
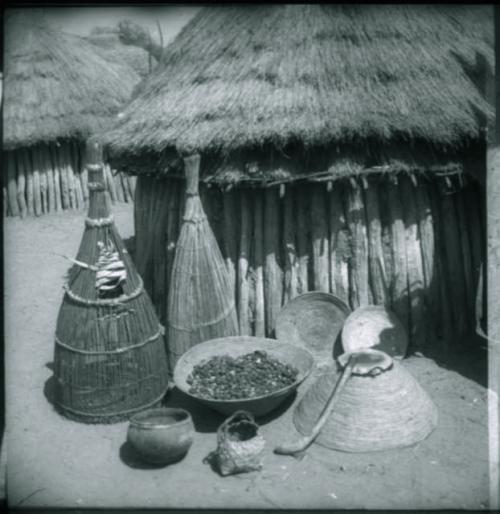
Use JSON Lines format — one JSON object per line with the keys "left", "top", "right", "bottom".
{"left": 167, "top": 155, "right": 238, "bottom": 373}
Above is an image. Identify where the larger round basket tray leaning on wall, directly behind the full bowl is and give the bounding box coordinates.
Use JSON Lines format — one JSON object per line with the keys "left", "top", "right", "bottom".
{"left": 276, "top": 291, "right": 351, "bottom": 362}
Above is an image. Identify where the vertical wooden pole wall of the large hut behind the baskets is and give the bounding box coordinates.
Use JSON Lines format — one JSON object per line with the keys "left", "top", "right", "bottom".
{"left": 135, "top": 172, "right": 484, "bottom": 349}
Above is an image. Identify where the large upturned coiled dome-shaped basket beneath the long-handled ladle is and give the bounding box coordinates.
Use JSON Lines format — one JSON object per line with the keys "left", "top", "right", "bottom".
{"left": 293, "top": 361, "right": 438, "bottom": 452}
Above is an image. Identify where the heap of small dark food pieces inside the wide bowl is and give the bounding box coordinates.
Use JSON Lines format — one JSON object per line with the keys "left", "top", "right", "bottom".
{"left": 186, "top": 350, "right": 299, "bottom": 400}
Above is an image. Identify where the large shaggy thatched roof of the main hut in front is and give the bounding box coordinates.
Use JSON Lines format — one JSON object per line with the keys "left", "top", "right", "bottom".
{"left": 107, "top": 4, "right": 494, "bottom": 170}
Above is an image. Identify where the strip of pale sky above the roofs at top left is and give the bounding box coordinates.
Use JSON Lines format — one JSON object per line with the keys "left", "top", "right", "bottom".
{"left": 6, "top": 4, "right": 201, "bottom": 44}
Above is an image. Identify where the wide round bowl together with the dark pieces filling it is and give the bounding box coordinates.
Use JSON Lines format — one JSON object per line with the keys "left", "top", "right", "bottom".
{"left": 174, "top": 336, "right": 314, "bottom": 417}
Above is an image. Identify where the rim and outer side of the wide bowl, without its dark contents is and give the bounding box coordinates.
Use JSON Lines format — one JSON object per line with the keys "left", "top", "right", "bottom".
{"left": 174, "top": 336, "right": 314, "bottom": 416}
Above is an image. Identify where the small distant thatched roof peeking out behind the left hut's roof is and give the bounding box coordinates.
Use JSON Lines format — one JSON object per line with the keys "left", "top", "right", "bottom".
{"left": 85, "top": 28, "right": 151, "bottom": 78}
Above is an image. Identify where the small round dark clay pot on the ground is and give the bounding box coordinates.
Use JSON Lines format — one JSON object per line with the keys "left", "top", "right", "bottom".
{"left": 127, "top": 407, "right": 195, "bottom": 464}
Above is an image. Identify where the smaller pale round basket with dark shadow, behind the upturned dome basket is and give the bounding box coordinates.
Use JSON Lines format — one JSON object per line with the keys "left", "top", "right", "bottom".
{"left": 342, "top": 305, "right": 408, "bottom": 359}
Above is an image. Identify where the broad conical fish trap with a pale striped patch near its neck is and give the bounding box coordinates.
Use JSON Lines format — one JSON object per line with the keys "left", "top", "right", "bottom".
{"left": 54, "top": 165, "right": 168, "bottom": 423}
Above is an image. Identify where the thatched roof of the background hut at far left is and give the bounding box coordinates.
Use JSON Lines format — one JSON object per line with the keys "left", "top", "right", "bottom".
{"left": 3, "top": 10, "right": 140, "bottom": 149}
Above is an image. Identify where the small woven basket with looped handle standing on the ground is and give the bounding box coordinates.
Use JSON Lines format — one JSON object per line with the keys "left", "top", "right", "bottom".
{"left": 216, "top": 411, "right": 265, "bottom": 476}
